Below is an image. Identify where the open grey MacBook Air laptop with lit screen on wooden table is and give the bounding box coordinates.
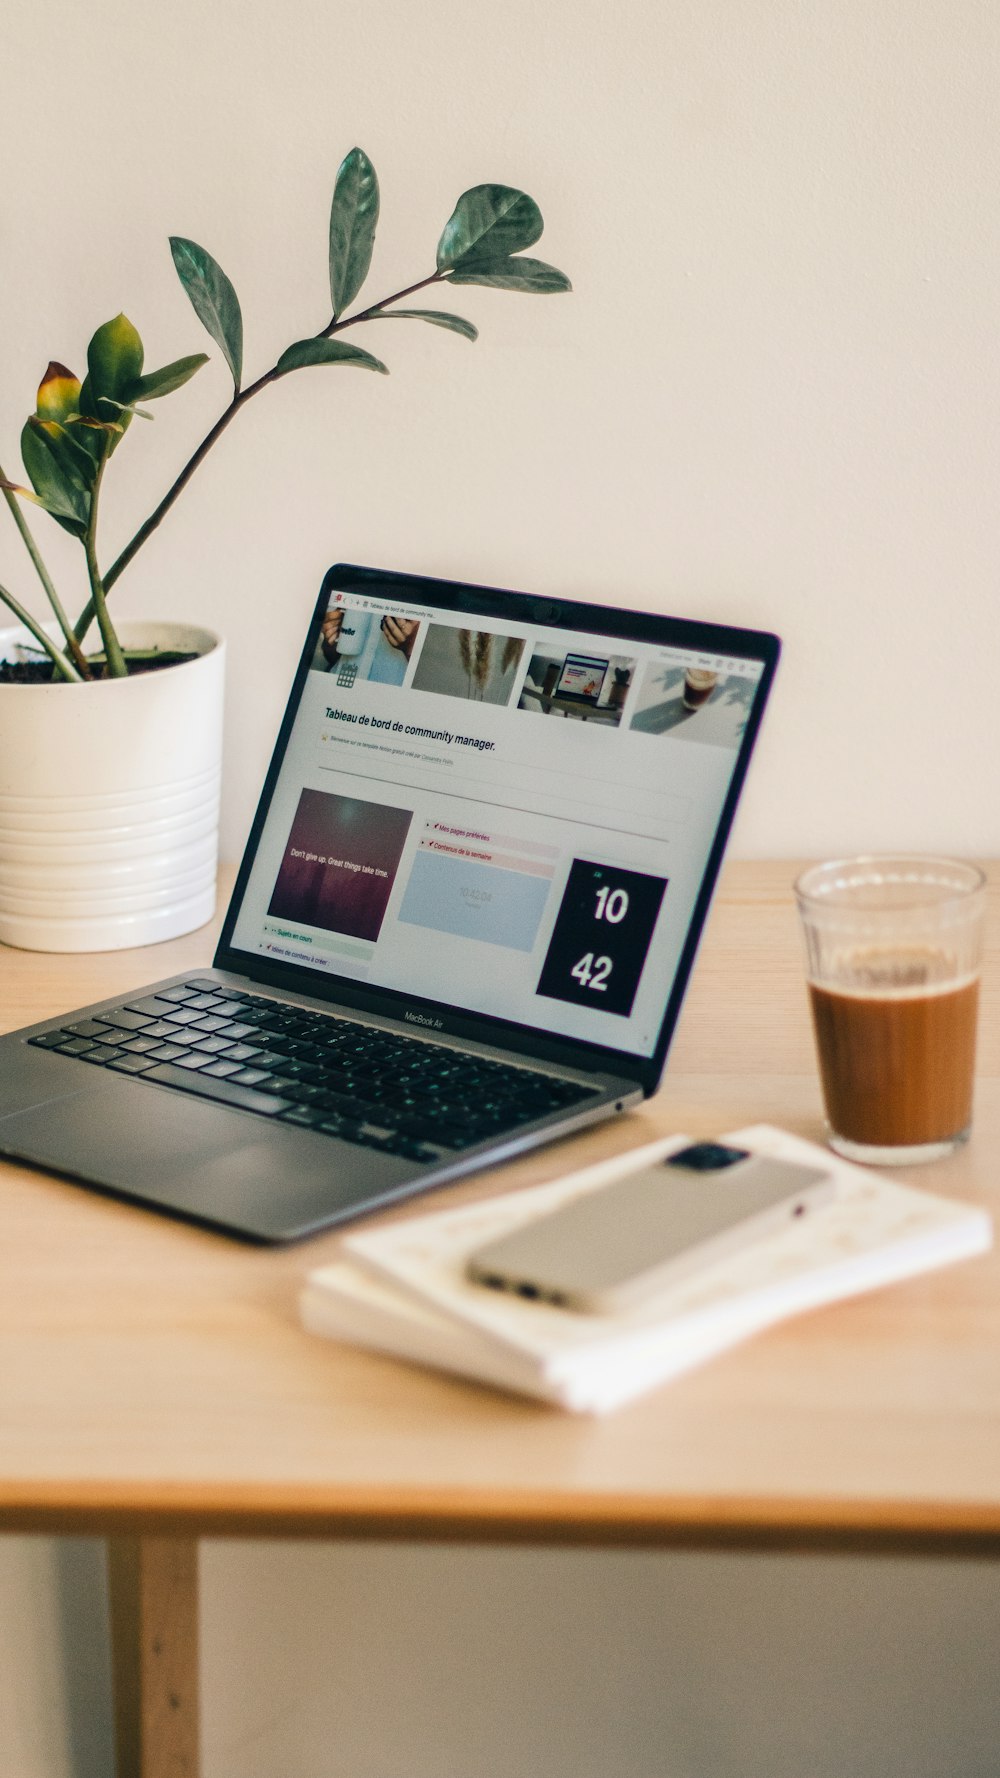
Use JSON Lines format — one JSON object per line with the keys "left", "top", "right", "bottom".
{"left": 0, "top": 564, "right": 779, "bottom": 1243}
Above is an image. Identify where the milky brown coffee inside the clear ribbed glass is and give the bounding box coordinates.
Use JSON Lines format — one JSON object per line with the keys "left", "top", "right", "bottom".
{"left": 810, "top": 969, "right": 979, "bottom": 1149}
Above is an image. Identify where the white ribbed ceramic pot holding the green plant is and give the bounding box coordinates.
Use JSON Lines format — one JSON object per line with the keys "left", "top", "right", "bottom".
{"left": 0, "top": 624, "right": 226, "bottom": 951}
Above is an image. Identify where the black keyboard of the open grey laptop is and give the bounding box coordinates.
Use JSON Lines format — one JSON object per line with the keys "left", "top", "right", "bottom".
{"left": 28, "top": 978, "right": 596, "bottom": 1161}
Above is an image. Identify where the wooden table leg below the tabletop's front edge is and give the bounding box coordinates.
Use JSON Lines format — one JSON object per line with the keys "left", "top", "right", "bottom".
{"left": 109, "top": 1538, "right": 199, "bottom": 1778}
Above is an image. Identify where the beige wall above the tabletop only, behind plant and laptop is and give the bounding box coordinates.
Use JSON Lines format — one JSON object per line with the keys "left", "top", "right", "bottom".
{"left": 0, "top": 0, "right": 1000, "bottom": 855}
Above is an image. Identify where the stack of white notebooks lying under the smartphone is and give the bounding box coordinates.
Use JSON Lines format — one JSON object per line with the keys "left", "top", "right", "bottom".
{"left": 301, "top": 1124, "right": 993, "bottom": 1414}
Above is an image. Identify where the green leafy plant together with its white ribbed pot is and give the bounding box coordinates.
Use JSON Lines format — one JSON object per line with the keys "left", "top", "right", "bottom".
{"left": 0, "top": 148, "right": 569, "bottom": 951}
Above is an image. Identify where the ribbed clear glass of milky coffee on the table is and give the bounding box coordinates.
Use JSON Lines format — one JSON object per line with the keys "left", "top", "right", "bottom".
{"left": 795, "top": 855, "right": 986, "bottom": 1165}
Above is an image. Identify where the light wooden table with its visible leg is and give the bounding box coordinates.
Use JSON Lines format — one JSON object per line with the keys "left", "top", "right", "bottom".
{"left": 0, "top": 862, "right": 1000, "bottom": 1778}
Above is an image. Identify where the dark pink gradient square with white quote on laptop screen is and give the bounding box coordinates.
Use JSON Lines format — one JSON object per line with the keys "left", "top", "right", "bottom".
{"left": 267, "top": 789, "right": 411, "bottom": 941}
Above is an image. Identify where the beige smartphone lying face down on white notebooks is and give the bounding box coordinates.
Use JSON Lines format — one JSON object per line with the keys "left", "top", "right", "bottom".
{"left": 466, "top": 1141, "right": 835, "bottom": 1314}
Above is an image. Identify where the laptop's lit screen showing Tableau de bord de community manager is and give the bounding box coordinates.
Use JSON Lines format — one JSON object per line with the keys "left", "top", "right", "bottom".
{"left": 226, "top": 569, "right": 778, "bottom": 1058}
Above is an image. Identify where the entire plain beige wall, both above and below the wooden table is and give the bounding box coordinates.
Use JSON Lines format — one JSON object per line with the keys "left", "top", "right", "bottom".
{"left": 0, "top": 0, "right": 1000, "bottom": 1778}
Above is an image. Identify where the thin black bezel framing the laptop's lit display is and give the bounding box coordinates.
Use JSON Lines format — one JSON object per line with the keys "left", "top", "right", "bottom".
{"left": 214, "top": 562, "right": 781, "bottom": 1095}
